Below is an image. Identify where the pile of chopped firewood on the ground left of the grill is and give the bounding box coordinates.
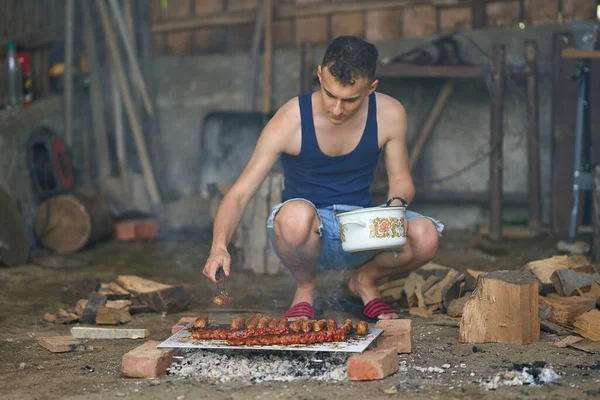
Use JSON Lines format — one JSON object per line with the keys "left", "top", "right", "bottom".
{"left": 43, "top": 275, "right": 192, "bottom": 325}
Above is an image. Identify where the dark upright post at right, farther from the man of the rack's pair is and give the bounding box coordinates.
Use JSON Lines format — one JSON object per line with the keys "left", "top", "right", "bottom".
{"left": 525, "top": 40, "right": 542, "bottom": 230}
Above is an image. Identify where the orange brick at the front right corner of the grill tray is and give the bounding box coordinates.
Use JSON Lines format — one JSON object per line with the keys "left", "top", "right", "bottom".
{"left": 346, "top": 349, "right": 398, "bottom": 381}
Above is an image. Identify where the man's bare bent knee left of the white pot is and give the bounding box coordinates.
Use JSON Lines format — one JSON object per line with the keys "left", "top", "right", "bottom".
{"left": 273, "top": 201, "right": 319, "bottom": 247}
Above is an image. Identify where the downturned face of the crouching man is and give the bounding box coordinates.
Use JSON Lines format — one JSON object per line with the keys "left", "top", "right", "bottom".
{"left": 317, "top": 65, "right": 377, "bottom": 125}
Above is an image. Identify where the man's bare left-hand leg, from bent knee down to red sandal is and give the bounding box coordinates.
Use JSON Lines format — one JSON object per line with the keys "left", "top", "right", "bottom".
{"left": 273, "top": 200, "right": 321, "bottom": 321}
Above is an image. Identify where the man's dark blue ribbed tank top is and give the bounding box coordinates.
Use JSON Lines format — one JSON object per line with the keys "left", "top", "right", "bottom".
{"left": 281, "top": 92, "right": 380, "bottom": 208}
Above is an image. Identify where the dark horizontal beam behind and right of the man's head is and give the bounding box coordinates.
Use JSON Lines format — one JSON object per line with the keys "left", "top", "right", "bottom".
{"left": 376, "top": 63, "right": 485, "bottom": 78}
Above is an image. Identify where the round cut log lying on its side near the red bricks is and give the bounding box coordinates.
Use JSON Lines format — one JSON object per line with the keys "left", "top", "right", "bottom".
{"left": 34, "top": 189, "right": 113, "bottom": 253}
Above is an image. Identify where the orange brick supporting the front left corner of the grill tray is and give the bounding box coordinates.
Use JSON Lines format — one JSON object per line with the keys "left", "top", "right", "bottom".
{"left": 121, "top": 340, "right": 180, "bottom": 378}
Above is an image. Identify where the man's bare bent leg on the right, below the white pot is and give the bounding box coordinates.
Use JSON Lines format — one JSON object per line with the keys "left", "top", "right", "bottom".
{"left": 348, "top": 218, "right": 439, "bottom": 319}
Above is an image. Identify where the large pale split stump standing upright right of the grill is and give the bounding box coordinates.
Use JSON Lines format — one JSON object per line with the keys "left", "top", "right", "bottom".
{"left": 459, "top": 270, "right": 540, "bottom": 344}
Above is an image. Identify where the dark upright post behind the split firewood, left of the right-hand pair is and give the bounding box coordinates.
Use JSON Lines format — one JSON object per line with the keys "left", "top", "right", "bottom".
{"left": 489, "top": 45, "right": 505, "bottom": 242}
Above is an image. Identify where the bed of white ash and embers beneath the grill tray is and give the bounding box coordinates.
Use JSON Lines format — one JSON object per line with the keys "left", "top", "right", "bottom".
{"left": 167, "top": 350, "right": 351, "bottom": 383}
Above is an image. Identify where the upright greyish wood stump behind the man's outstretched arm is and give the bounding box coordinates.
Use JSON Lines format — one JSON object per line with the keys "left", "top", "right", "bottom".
{"left": 209, "top": 172, "right": 284, "bottom": 275}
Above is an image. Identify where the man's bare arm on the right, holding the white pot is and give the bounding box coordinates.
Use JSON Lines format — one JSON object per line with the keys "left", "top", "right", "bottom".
{"left": 384, "top": 99, "right": 415, "bottom": 204}
